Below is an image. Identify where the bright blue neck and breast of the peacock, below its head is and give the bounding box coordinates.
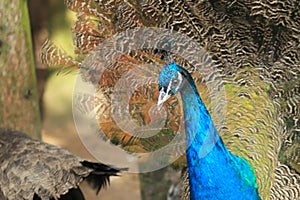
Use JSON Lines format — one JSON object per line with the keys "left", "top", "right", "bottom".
{"left": 181, "top": 76, "right": 260, "bottom": 200}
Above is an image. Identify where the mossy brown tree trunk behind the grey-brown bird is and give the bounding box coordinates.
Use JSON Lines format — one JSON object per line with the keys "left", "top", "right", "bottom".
{"left": 0, "top": 0, "right": 41, "bottom": 138}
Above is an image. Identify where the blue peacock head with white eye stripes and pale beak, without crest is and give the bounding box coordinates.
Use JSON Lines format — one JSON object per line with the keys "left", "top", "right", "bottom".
{"left": 157, "top": 62, "right": 188, "bottom": 109}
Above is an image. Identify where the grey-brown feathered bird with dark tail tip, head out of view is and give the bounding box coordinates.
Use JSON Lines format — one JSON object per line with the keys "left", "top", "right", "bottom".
{"left": 0, "top": 128, "right": 125, "bottom": 200}
